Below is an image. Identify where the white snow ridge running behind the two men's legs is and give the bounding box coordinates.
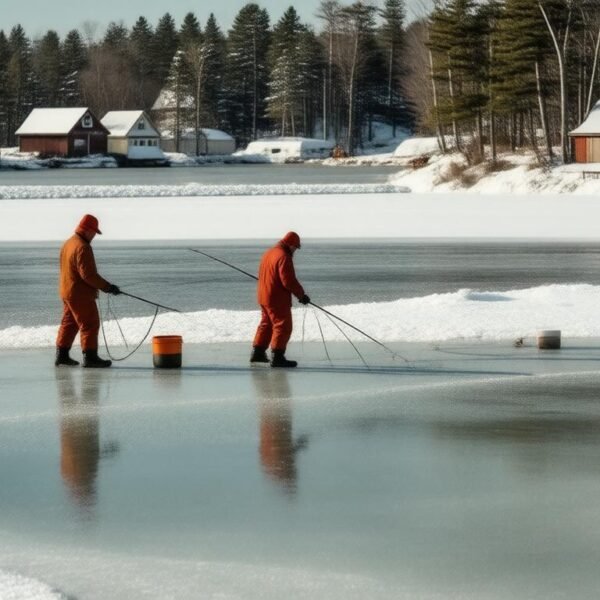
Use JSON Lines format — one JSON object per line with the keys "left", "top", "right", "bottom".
{"left": 0, "top": 284, "right": 600, "bottom": 348}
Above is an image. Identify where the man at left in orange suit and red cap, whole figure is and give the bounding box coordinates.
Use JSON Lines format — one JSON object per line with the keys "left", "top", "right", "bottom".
{"left": 54, "top": 215, "right": 121, "bottom": 368}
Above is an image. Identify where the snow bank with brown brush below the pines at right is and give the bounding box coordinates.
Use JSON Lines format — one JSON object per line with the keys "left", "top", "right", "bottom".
{"left": 390, "top": 150, "right": 600, "bottom": 195}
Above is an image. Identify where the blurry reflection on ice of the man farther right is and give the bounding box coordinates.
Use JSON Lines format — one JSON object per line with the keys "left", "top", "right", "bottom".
{"left": 252, "top": 370, "right": 308, "bottom": 495}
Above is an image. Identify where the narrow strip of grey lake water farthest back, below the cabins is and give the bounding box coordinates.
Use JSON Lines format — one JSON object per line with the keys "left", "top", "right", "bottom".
{"left": 0, "top": 164, "right": 400, "bottom": 186}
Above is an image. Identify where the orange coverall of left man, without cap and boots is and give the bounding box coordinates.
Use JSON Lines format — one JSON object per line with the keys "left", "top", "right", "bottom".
{"left": 56, "top": 234, "right": 110, "bottom": 352}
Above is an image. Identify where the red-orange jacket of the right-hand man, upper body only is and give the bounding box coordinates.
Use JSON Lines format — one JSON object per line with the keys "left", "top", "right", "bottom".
{"left": 257, "top": 242, "right": 304, "bottom": 308}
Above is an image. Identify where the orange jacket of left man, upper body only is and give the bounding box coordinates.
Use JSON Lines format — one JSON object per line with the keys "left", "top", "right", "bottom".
{"left": 59, "top": 234, "right": 110, "bottom": 301}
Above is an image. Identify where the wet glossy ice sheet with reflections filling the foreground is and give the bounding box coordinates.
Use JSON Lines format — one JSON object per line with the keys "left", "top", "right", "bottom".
{"left": 0, "top": 340, "right": 600, "bottom": 599}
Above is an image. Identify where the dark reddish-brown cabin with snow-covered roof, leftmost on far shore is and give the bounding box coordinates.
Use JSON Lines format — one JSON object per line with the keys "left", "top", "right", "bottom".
{"left": 16, "top": 108, "right": 108, "bottom": 157}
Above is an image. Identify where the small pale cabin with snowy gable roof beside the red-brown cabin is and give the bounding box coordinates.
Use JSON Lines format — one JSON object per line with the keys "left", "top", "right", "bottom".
{"left": 102, "top": 110, "right": 166, "bottom": 162}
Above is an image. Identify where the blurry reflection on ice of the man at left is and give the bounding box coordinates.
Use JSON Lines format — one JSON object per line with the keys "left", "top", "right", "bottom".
{"left": 56, "top": 368, "right": 119, "bottom": 516}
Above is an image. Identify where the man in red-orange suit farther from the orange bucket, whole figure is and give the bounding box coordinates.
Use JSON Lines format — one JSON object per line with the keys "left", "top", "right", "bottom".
{"left": 250, "top": 231, "right": 310, "bottom": 367}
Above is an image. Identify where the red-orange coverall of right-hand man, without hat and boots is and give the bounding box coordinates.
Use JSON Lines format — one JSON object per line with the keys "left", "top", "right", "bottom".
{"left": 253, "top": 242, "right": 304, "bottom": 352}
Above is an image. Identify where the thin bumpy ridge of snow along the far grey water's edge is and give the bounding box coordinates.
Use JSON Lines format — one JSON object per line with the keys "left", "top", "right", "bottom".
{"left": 0, "top": 183, "right": 408, "bottom": 200}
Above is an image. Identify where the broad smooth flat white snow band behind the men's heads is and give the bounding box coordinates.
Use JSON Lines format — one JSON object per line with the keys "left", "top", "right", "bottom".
{"left": 0, "top": 188, "right": 600, "bottom": 242}
